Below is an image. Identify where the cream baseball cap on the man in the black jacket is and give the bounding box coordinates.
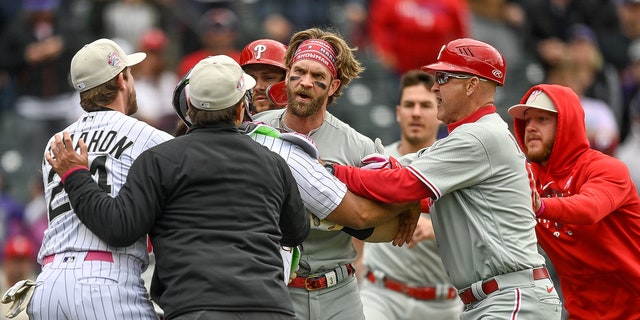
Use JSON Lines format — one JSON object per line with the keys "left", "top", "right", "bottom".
{"left": 187, "top": 55, "right": 256, "bottom": 111}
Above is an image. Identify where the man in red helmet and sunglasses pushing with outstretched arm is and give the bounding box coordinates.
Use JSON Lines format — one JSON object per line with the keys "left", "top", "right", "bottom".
{"left": 334, "top": 38, "right": 561, "bottom": 320}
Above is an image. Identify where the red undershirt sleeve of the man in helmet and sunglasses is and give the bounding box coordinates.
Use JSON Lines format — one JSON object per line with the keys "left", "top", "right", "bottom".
{"left": 334, "top": 164, "right": 434, "bottom": 203}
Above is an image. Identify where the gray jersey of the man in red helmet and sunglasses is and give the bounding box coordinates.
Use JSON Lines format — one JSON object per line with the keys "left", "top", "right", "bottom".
{"left": 400, "top": 113, "right": 544, "bottom": 289}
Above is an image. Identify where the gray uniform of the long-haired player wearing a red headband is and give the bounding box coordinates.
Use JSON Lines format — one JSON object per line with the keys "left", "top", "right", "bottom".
{"left": 255, "top": 109, "right": 376, "bottom": 319}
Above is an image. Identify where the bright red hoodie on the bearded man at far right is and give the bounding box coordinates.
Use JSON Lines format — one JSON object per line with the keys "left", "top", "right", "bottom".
{"left": 514, "top": 84, "right": 640, "bottom": 320}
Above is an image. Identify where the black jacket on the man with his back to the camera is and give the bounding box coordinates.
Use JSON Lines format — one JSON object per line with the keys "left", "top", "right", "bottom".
{"left": 65, "top": 124, "right": 309, "bottom": 318}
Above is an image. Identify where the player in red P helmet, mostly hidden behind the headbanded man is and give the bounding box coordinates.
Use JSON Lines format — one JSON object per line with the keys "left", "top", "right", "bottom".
{"left": 240, "top": 39, "right": 287, "bottom": 114}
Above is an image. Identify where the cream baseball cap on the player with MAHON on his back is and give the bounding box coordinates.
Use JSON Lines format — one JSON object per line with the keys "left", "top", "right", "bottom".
{"left": 71, "top": 39, "right": 147, "bottom": 92}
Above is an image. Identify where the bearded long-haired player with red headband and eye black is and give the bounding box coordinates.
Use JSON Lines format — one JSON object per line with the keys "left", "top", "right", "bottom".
{"left": 256, "top": 28, "right": 376, "bottom": 320}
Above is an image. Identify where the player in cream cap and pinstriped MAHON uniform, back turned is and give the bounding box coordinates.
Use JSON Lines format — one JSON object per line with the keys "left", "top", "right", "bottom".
{"left": 27, "top": 39, "right": 172, "bottom": 320}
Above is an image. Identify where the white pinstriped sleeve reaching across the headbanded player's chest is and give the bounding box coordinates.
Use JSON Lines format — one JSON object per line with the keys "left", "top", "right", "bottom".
{"left": 250, "top": 133, "right": 347, "bottom": 219}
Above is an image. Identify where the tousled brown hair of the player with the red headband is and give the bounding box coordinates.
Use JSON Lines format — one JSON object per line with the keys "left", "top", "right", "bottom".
{"left": 284, "top": 28, "right": 364, "bottom": 104}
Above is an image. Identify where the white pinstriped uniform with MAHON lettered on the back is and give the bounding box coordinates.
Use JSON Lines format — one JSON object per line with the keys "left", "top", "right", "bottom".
{"left": 27, "top": 111, "right": 172, "bottom": 319}
